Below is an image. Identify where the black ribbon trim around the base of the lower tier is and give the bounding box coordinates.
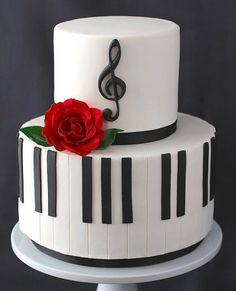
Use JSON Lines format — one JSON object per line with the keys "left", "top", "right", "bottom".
{"left": 32, "top": 241, "right": 202, "bottom": 268}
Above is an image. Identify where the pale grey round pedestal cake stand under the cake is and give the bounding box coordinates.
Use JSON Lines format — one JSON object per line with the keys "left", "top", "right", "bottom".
{"left": 11, "top": 222, "right": 222, "bottom": 291}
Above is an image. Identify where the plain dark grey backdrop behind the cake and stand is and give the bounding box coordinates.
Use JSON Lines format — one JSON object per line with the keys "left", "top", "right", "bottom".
{"left": 0, "top": 0, "right": 236, "bottom": 291}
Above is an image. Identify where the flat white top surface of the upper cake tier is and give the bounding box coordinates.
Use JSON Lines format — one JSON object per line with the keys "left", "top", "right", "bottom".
{"left": 55, "top": 16, "right": 179, "bottom": 37}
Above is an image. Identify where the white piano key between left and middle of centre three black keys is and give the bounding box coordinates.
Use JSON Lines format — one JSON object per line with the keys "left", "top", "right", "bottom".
{"left": 88, "top": 158, "right": 108, "bottom": 259}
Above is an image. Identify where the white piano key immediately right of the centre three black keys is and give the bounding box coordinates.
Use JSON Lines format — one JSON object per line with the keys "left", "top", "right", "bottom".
{"left": 128, "top": 158, "right": 147, "bottom": 258}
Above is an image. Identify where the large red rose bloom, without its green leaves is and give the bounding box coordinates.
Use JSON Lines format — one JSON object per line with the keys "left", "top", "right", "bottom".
{"left": 42, "top": 99, "right": 104, "bottom": 156}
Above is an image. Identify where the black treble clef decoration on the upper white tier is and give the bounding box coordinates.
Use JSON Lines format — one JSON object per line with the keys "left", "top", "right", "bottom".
{"left": 98, "top": 39, "right": 126, "bottom": 121}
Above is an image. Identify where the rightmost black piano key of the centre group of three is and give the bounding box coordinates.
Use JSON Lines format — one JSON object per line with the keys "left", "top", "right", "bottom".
{"left": 121, "top": 158, "right": 133, "bottom": 223}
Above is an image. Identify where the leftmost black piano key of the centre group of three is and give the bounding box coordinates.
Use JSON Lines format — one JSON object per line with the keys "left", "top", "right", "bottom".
{"left": 82, "top": 157, "right": 92, "bottom": 223}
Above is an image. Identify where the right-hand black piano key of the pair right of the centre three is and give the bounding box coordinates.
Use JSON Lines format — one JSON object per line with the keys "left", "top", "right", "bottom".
{"left": 177, "top": 151, "right": 186, "bottom": 217}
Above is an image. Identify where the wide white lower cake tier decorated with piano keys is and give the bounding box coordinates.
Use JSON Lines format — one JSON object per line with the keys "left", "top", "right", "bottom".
{"left": 18, "top": 114, "right": 215, "bottom": 266}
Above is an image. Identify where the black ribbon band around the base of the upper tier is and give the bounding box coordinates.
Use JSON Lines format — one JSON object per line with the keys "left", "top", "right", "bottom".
{"left": 113, "top": 120, "right": 177, "bottom": 145}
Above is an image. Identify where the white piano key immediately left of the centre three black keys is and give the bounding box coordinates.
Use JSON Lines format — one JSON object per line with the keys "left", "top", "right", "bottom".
{"left": 69, "top": 155, "right": 88, "bottom": 257}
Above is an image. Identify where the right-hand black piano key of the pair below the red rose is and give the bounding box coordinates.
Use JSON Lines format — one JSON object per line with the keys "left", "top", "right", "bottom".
{"left": 47, "top": 150, "right": 57, "bottom": 217}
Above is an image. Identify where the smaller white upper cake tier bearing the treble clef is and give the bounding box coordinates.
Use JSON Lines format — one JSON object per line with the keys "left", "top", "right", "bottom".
{"left": 54, "top": 16, "right": 179, "bottom": 143}
